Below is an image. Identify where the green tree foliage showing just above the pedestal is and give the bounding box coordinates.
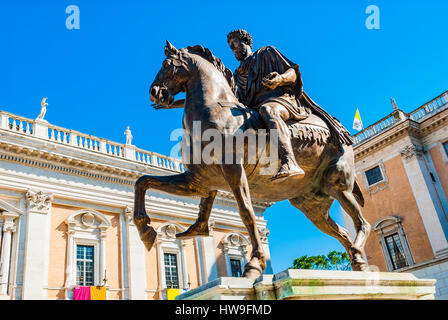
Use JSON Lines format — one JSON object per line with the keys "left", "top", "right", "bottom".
{"left": 292, "top": 251, "right": 351, "bottom": 271}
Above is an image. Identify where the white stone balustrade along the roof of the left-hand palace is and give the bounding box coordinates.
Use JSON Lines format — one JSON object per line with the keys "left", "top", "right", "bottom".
{"left": 0, "top": 111, "right": 185, "bottom": 172}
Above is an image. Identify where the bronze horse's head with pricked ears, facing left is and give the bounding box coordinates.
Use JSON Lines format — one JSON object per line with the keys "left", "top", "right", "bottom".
{"left": 149, "top": 41, "right": 189, "bottom": 106}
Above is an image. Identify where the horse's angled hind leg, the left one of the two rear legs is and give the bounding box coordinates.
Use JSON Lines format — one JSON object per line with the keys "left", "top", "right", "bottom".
{"left": 289, "top": 194, "right": 353, "bottom": 268}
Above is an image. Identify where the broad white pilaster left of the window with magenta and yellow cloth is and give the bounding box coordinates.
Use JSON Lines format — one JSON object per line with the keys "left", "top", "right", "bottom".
{"left": 22, "top": 190, "right": 53, "bottom": 300}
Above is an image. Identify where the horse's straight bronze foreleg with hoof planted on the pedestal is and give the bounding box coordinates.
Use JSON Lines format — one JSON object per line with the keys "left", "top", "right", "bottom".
{"left": 222, "top": 164, "right": 266, "bottom": 279}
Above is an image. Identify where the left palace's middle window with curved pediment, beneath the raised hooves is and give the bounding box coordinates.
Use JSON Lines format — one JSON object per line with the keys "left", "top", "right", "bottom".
{"left": 157, "top": 222, "right": 190, "bottom": 299}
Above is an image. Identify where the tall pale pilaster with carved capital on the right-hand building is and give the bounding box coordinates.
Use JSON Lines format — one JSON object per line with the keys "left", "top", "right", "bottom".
{"left": 400, "top": 144, "right": 448, "bottom": 256}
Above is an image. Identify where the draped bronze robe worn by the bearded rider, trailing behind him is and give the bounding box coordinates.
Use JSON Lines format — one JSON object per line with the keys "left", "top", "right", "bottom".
{"left": 234, "top": 46, "right": 353, "bottom": 145}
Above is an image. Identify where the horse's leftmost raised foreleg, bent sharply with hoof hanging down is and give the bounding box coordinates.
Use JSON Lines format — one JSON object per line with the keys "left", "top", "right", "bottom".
{"left": 134, "top": 171, "right": 204, "bottom": 251}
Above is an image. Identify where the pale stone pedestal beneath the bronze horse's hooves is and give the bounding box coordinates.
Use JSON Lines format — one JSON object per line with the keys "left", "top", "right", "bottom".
{"left": 176, "top": 269, "right": 436, "bottom": 300}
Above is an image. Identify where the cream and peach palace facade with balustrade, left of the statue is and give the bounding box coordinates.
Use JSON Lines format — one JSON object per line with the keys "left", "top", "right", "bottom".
{"left": 0, "top": 111, "right": 272, "bottom": 300}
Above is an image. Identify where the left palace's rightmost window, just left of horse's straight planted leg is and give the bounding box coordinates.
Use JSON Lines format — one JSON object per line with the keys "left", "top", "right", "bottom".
{"left": 221, "top": 232, "right": 249, "bottom": 277}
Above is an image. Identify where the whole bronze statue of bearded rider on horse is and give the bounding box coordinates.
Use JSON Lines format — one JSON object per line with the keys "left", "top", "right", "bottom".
{"left": 134, "top": 30, "right": 370, "bottom": 279}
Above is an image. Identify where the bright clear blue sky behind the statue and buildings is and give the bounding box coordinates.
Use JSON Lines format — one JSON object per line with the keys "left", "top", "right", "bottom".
{"left": 0, "top": 0, "right": 448, "bottom": 272}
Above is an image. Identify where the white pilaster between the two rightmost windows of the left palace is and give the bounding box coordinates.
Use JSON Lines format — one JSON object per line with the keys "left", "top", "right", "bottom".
{"left": 199, "top": 219, "right": 218, "bottom": 283}
